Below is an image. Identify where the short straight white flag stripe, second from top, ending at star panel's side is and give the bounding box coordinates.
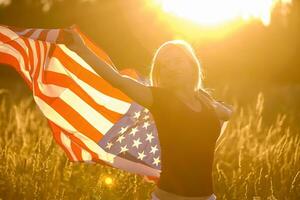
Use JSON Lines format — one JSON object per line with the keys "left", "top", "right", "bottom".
{"left": 60, "top": 89, "right": 113, "bottom": 135}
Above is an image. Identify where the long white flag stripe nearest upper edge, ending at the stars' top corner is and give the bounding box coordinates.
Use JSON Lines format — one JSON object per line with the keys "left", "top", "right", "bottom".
{"left": 46, "top": 57, "right": 131, "bottom": 114}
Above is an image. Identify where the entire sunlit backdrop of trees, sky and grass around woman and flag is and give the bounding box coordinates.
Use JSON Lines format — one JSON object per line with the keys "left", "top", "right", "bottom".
{"left": 0, "top": 0, "right": 300, "bottom": 200}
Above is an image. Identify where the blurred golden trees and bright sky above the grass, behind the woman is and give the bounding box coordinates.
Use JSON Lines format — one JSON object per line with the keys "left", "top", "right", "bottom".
{"left": 0, "top": 0, "right": 300, "bottom": 122}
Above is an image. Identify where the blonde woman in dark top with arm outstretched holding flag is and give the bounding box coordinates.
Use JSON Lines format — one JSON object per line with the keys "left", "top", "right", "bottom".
{"left": 66, "top": 30, "right": 232, "bottom": 200}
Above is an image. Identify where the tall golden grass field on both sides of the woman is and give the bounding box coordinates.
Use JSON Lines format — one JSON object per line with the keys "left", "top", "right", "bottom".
{"left": 0, "top": 90, "right": 300, "bottom": 200}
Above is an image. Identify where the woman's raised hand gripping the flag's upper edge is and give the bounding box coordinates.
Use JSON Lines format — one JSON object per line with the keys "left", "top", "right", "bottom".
{"left": 63, "top": 29, "right": 86, "bottom": 53}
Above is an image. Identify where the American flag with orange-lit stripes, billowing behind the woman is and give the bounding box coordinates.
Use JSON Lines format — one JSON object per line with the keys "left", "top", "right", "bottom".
{"left": 0, "top": 25, "right": 161, "bottom": 181}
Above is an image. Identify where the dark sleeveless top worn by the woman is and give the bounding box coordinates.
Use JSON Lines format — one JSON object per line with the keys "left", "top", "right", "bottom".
{"left": 148, "top": 86, "right": 221, "bottom": 196}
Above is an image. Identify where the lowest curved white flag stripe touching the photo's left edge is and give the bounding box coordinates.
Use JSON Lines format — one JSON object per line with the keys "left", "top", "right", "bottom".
{"left": 0, "top": 44, "right": 32, "bottom": 82}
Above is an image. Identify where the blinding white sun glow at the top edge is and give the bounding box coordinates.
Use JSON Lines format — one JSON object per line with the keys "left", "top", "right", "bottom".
{"left": 155, "top": 0, "right": 292, "bottom": 26}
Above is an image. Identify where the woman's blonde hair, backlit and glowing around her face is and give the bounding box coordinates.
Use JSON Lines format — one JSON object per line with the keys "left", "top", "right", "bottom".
{"left": 150, "top": 40, "right": 204, "bottom": 91}
